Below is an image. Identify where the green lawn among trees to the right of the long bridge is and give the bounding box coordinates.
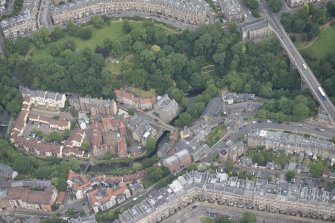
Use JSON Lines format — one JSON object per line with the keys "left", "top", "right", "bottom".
{"left": 304, "top": 26, "right": 335, "bottom": 59}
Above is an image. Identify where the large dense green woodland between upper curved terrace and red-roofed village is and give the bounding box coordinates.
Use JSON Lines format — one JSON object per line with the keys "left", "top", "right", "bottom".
{"left": 0, "top": 20, "right": 315, "bottom": 122}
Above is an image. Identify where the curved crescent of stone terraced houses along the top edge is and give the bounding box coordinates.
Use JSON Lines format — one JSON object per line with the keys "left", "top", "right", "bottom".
{"left": 52, "top": 0, "right": 208, "bottom": 25}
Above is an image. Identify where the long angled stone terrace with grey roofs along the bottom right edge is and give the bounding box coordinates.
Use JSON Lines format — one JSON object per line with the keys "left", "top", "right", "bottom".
{"left": 119, "top": 172, "right": 335, "bottom": 223}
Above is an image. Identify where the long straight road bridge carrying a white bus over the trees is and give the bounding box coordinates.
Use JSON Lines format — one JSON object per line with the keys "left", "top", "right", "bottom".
{"left": 261, "top": 0, "right": 335, "bottom": 123}
